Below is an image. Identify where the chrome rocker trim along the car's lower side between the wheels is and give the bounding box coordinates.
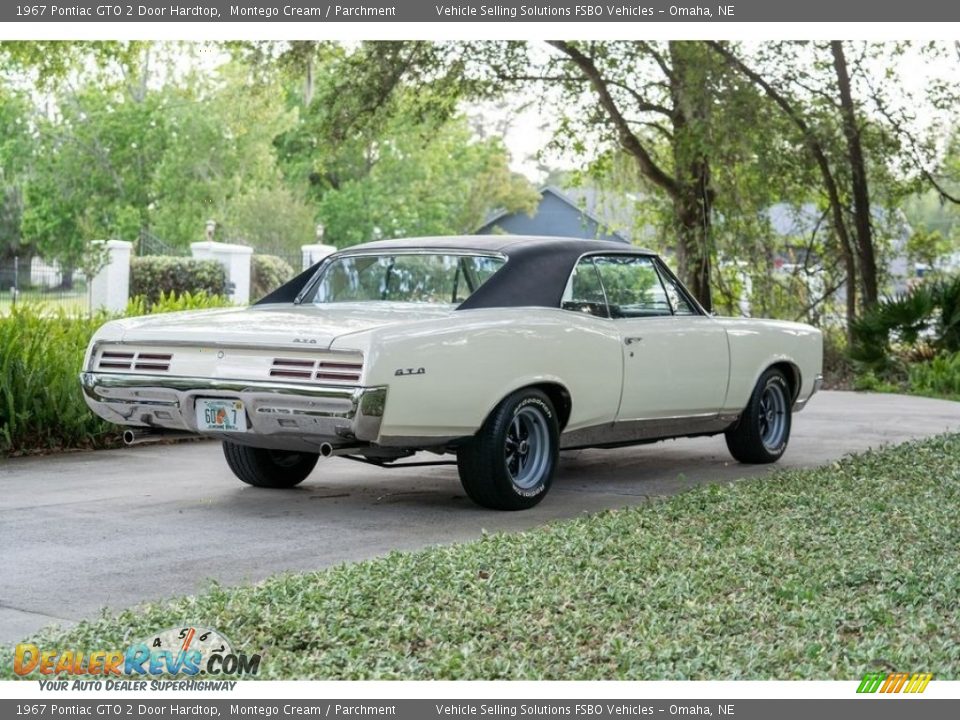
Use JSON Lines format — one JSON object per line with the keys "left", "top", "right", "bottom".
{"left": 560, "top": 413, "right": 740, "bottom": 450}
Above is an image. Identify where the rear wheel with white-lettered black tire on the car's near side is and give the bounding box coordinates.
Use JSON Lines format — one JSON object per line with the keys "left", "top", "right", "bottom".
{"left": 457, "top": 388, "right": 560, "bottom": 510}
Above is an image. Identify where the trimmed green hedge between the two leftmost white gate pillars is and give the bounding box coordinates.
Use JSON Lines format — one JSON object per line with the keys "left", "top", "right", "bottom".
{"left": 130, "top": 255, "right": 227, "bottom": 307}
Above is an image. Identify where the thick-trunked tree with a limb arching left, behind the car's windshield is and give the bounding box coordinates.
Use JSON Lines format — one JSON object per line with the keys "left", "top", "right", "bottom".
{"left": 492, "top": 40, "right": 722, "bottom": 310}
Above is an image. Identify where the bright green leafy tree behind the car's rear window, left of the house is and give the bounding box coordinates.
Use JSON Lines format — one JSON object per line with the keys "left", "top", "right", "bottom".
{"left": 261, "top": 43, "right": 538, "bottom": 247}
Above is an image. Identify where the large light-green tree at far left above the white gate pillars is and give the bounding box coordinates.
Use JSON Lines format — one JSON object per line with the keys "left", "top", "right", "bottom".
{"left": 17, "top": 46, "right": 313, "bottom": 266}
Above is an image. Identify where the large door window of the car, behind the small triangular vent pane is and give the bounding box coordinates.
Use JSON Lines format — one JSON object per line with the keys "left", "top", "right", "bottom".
{"left": 594, "top": 255, "right": 673, "bottom": 318}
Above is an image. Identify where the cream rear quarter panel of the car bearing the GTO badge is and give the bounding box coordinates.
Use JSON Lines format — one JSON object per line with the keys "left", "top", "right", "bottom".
{"left": 331, "top": 308, "right": 623, "bottom": 441}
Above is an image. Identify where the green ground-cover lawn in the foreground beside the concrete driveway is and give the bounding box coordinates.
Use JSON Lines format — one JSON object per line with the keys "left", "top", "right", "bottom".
{"left": 0, "top": 436, "right": 960, "bottom": 680}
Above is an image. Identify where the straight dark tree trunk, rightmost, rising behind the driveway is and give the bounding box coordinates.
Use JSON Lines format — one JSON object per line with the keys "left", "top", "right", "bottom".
{"left": 830, "top": 40, "right": 879, "bottom": 308}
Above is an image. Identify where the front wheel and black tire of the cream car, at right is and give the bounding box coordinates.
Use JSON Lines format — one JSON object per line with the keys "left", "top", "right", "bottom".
{"left": 726, "top": 368, "right": 793, "bottom": 465}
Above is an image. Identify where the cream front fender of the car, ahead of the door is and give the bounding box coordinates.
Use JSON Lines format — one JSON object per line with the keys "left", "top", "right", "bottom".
{"left": 717, "top": 318, "right": 823, "bottom": 412}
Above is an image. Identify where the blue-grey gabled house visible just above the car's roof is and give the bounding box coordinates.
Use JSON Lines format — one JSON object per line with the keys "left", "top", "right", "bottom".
{"left": 476, "top": 185, "right": 630, "bottom": 243}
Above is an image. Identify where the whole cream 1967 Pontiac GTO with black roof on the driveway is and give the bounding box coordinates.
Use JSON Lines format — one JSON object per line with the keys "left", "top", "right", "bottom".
{"left": 81, "top": 236, "right": 822, "bottom": 510}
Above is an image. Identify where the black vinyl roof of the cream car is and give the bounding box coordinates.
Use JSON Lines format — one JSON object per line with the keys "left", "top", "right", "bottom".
{"left": 257, "top": 235, "right": 655, "bottom": 310}
